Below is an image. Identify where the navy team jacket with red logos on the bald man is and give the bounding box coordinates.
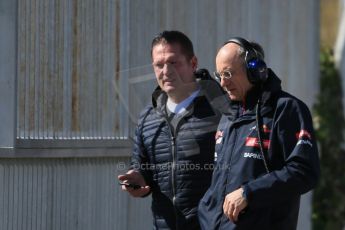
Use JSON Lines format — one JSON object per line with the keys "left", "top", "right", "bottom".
{"left": 198, "top": 70, "right": 320, "bottom": 230}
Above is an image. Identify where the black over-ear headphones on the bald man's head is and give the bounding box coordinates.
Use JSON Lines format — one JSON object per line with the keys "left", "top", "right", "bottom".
{"left": 223, "top": 37, "right": 268, "bottom": 85}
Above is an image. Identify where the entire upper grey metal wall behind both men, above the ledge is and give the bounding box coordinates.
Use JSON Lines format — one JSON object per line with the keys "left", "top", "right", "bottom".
{"left": 12, "top": 0, "right": 319, "bottom": 139}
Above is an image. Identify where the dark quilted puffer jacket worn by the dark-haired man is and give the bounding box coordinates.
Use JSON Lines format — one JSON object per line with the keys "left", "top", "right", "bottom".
{"left": 132, "top": 78, "right": 220, "bottom": 230}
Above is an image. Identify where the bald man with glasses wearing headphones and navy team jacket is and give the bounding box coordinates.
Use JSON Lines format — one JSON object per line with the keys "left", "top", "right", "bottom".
{"left": 199, "top": 37, "right": 320, "bottom": 230}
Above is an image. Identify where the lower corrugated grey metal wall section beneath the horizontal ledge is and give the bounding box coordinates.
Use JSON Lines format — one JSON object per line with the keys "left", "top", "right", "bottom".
{"left": 0, "top": 158, "right": 152, "bottom": 230}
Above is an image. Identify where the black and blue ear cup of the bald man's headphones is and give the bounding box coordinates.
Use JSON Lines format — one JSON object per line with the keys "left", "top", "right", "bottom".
{"left": 247, "top": 59, "right": 268, "bottom": 85}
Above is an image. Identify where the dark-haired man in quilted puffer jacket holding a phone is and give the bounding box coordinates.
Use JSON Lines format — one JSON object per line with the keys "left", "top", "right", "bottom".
{"left": 118, "top": 31, "right": 227, "bottom": 230}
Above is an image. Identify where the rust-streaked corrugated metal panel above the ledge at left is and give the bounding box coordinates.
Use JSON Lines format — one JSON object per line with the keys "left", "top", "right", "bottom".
{"left": 17, "top": 0, "right": 129, "bottom": 139}
